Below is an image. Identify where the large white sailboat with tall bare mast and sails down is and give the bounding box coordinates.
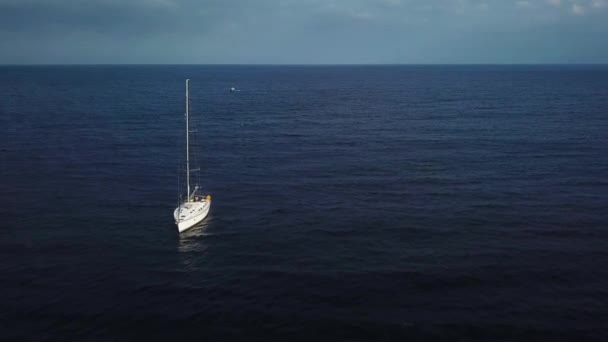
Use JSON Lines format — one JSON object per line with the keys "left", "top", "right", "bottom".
{"left": 173, "top": 79, "right": 211, "bottom": 233}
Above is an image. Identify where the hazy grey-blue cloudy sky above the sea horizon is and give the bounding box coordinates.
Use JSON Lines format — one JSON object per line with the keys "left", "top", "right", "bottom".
{"left": 0, "top": 0, "right": 608, "bottom": 64}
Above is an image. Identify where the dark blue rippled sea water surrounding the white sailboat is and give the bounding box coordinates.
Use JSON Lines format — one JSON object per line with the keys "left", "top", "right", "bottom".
{"left": 0, "top": 66, "right": 608, "bottom": 341}
